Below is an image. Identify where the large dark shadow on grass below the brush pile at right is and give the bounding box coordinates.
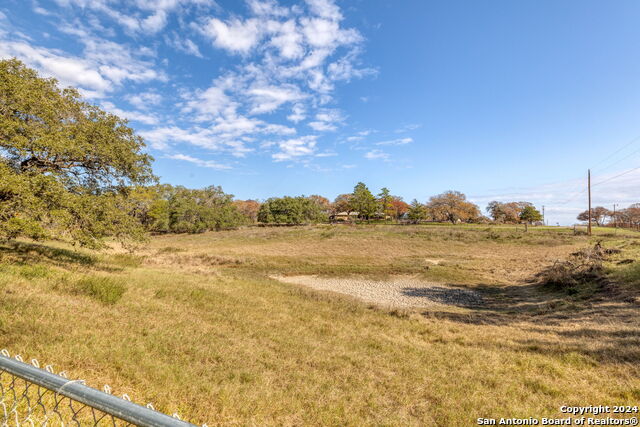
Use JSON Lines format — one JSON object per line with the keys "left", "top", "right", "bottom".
{"left": 407, "top": 283, "right": 640, "bottom": 366}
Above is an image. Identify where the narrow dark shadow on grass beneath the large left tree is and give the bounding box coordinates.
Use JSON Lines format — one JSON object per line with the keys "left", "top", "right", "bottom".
{"left": 0, "top": 242, "right": 98, "bottom": 266}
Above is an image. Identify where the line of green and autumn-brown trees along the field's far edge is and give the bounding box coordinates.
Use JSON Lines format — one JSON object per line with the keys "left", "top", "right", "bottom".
{"left": 0, "top": 59, "right": 552, "bottom": 247}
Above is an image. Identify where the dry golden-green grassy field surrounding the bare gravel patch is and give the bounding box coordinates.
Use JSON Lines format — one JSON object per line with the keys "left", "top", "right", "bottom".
{"left": 0, "top": 225, "right": 640, "bottom": 426}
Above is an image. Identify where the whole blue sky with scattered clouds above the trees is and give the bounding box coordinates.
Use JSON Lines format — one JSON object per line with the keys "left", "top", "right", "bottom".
{"left": 0, "top": 0, "right": 640, "bottom": 224}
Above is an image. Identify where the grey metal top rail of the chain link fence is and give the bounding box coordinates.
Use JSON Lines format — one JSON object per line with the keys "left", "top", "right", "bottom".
{"left": 0, "top": 355, "right": 194, "bottom": 427}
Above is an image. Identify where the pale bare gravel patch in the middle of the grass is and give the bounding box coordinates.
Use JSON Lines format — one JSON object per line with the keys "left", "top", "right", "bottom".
{"left": 274, "top": 276, "right": 482, "bottom": 308}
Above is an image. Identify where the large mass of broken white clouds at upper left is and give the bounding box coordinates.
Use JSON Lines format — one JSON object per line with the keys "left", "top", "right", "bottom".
{"left": 23, "top": 0, "right": 372, "bottom": 166}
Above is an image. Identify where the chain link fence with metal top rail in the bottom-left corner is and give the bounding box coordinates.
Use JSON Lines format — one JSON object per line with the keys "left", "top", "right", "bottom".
{"left": 0, "top": 350, "right": 206, "bottom": 427}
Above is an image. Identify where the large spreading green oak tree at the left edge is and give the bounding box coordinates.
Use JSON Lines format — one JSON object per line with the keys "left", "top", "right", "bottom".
{"left": 0, "top": 59, "right": 155, "bottom": 247}
